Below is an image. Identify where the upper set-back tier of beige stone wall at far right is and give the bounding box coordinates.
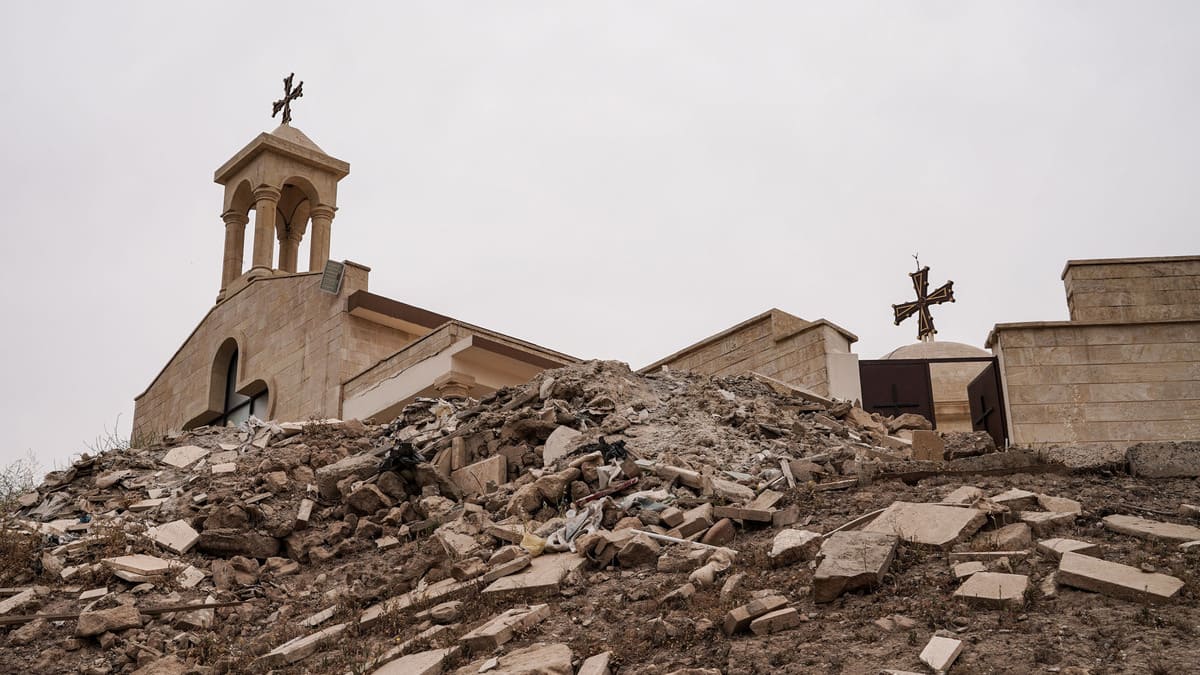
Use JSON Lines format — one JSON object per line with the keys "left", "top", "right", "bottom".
{"left": 1063, "top": 256, "right": 1200, "bottom": 323}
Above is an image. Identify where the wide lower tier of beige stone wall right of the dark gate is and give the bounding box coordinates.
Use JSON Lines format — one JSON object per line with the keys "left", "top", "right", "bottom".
{"left": 990, "top": 321, "right": 1200, "bottom": 447}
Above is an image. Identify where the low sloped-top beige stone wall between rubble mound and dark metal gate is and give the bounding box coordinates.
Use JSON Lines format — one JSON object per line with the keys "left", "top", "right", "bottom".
{"left": 641, "top": 309, "right": 862, "bottom": 400}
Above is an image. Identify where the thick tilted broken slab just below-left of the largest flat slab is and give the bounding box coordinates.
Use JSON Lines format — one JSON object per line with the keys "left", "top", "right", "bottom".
{"left": 812, "top": 528, "right": 897, "bottom": 603}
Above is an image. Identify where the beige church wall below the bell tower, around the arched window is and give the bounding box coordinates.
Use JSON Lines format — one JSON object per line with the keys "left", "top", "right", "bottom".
{"left": 133, "top": 268, "right": 409, "bottom": 436}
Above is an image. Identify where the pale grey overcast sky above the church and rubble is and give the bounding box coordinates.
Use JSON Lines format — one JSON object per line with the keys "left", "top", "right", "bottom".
{"left": 0, "top": 0, "right": 1200, "bottom": 467}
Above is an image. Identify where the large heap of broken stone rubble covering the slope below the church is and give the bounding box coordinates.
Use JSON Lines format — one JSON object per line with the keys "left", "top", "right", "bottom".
{"left": 0, "top": 362, "right": 1200, "bottom": 675}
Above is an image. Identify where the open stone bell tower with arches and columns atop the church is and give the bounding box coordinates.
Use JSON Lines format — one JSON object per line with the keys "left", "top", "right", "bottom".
{"left": 214, "top": 89, "right": 350, "bottom": 303}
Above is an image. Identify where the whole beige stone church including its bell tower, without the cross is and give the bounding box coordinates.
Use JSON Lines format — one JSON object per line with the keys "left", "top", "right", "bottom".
{"left": 133, "top": 125, "right": 577, "bottom": 438}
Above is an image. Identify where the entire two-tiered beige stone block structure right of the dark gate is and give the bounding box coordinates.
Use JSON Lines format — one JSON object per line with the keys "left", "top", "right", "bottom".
{"left": 988, "top": 257, "right": 1200, "bottom": 447}
